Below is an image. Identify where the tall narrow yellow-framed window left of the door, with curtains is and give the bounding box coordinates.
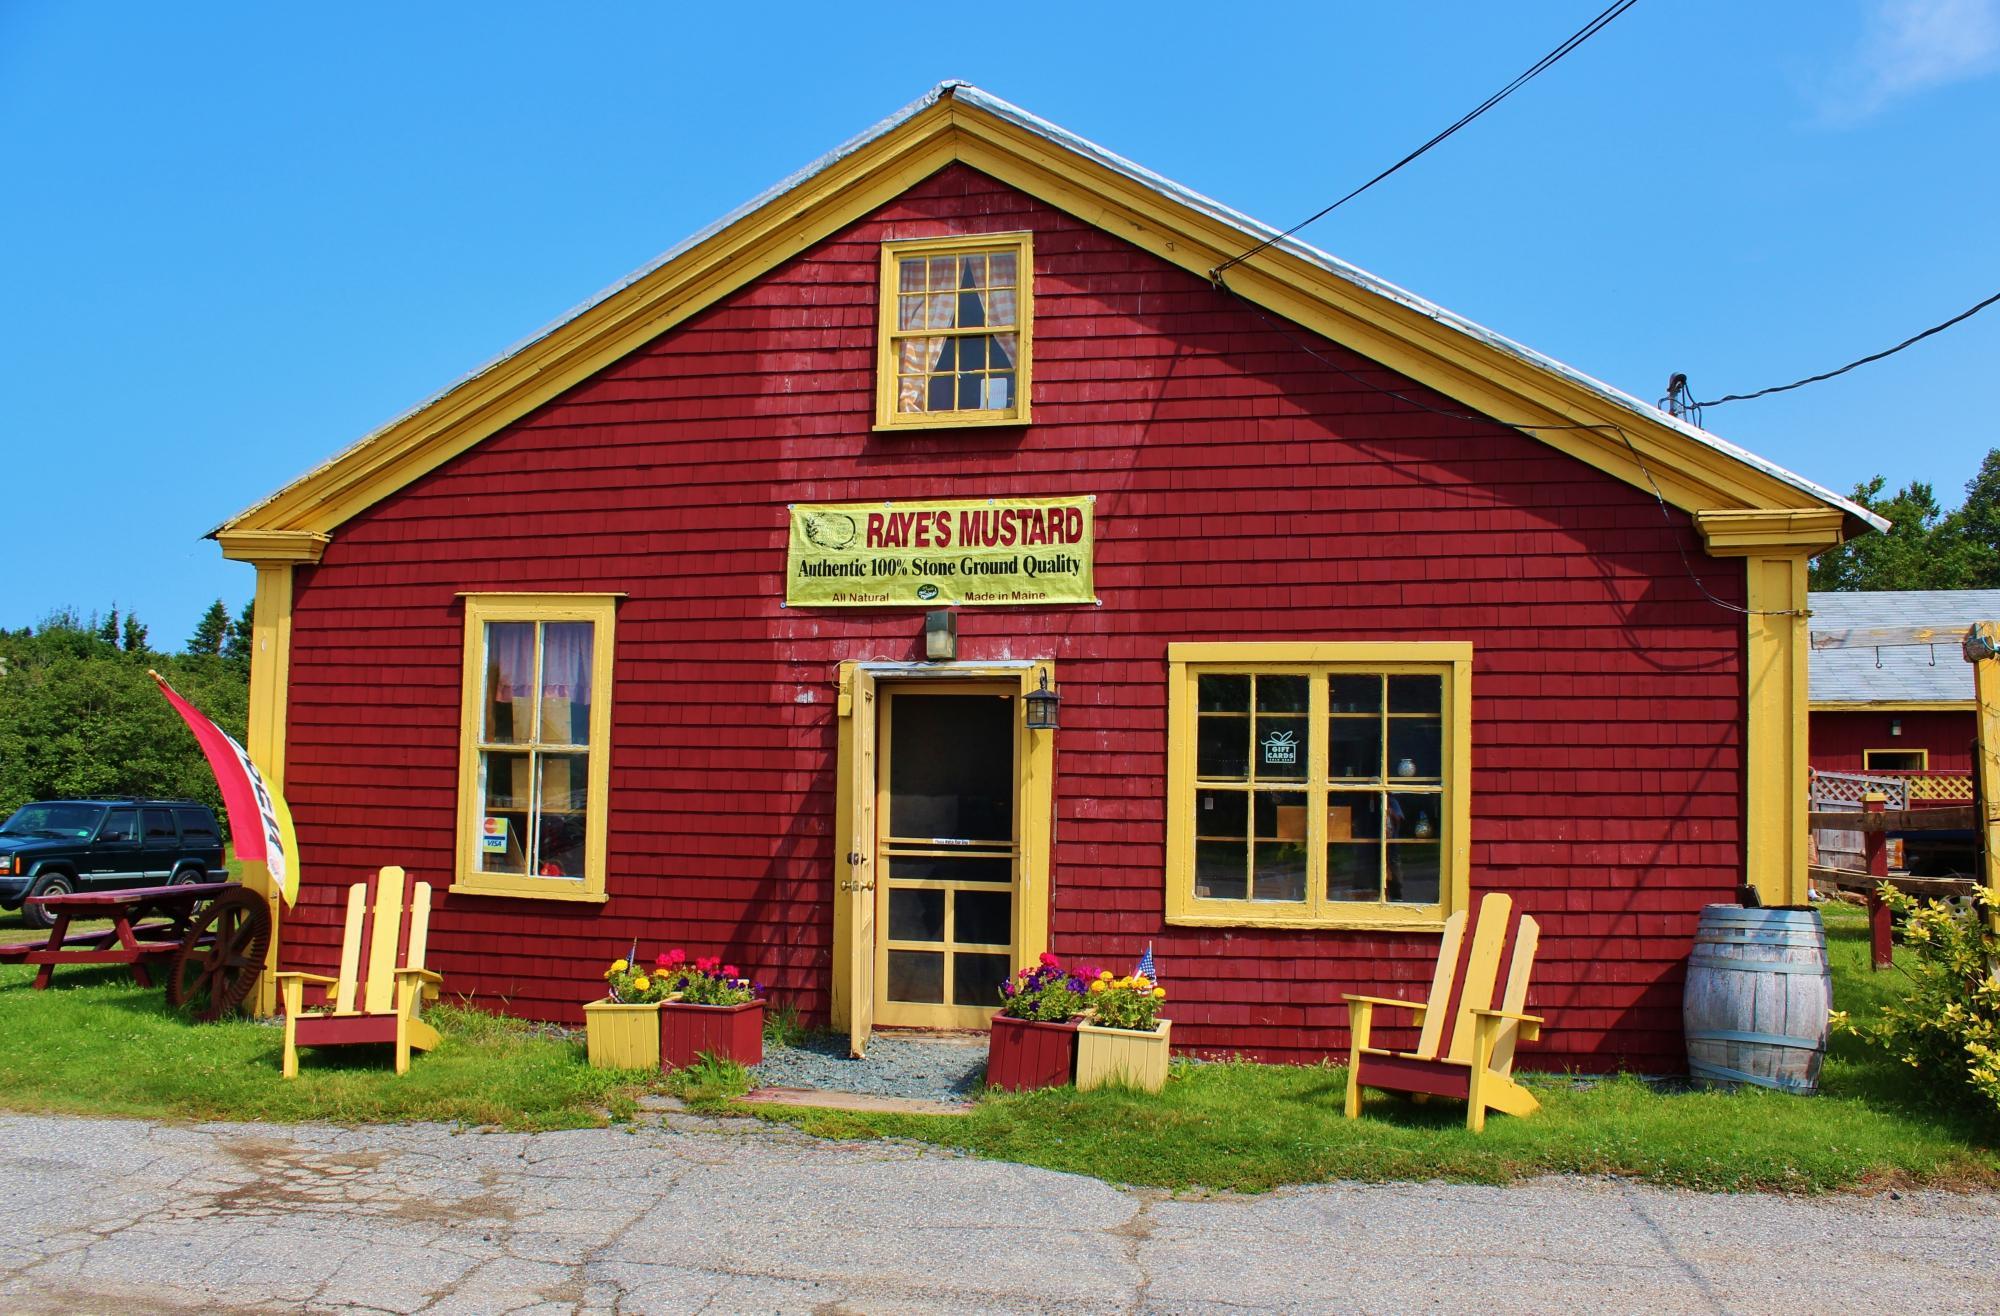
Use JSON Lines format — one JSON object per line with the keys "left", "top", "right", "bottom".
{"left": 452, "top": 594, "right": 618, "bottom": 900}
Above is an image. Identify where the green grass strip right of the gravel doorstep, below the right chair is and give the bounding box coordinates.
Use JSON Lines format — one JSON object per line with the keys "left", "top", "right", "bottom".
{"left": 740, "top": 906, "right": 2000, "bottom": 1192}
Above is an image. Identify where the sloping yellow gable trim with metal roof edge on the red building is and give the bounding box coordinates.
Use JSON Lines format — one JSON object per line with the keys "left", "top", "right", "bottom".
{"left": 210, "top": 78, "right": 1888, "bottom": 556}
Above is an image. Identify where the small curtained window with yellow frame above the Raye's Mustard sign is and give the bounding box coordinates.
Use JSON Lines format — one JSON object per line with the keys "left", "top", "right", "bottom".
{"left": 876, "top": 234, "right": 1034, "bottom": 428}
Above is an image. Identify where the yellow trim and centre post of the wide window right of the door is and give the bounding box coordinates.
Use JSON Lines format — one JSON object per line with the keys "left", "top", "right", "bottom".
{"left": 1166, "top": 640, "right": 1472, "bottom": 932}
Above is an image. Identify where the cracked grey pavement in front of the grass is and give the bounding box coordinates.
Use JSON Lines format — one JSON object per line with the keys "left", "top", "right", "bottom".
{"left": 0, "top": 1114, "right": 2000, "bottom": 1316}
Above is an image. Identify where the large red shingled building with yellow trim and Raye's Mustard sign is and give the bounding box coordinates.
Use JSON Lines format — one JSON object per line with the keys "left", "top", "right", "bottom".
{"left": 218, "top": 84, "right": 1868, "bottom": 1070}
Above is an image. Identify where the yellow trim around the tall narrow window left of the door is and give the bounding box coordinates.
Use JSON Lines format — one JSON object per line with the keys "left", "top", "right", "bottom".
{"left": 450, "top": 594, "right": 622, "bottom": 904}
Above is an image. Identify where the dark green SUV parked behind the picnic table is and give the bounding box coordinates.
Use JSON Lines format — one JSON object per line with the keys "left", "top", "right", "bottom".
{"left": 0, "top": 800, "right": 228, "bottom": 928}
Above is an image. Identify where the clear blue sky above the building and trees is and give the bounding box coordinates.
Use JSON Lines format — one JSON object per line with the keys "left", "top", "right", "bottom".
{"left": 0, "top": 0, "right": 2000, "bottom": 646}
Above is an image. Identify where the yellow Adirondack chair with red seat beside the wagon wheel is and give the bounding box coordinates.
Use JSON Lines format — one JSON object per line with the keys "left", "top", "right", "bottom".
{"left": 278, "top": 866, "right": 444, "bottom": 1078}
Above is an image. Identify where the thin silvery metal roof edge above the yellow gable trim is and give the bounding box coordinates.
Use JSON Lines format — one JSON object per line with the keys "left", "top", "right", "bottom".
{"left": 219, "top": 78, "right": 1890, "bottom": 538}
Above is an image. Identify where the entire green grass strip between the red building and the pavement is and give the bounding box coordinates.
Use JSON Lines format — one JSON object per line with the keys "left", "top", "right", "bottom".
{"left": 0, "top": 906, "right": 2000, "bottom": 1190}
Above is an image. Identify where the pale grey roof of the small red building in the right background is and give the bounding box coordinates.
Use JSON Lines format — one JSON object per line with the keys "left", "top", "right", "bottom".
{"left": 1806, "top": 590, "right": 2000, "bottom": 706}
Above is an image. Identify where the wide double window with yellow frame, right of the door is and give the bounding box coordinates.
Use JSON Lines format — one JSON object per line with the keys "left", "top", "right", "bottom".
{"left": 1166, "top": 642, "right": 1472, "bottom": 930}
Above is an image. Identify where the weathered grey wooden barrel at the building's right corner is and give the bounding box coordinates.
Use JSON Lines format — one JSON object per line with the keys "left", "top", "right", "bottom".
{"left": 1680, "top": 904, "right": 1834, "bottom": 1094}
